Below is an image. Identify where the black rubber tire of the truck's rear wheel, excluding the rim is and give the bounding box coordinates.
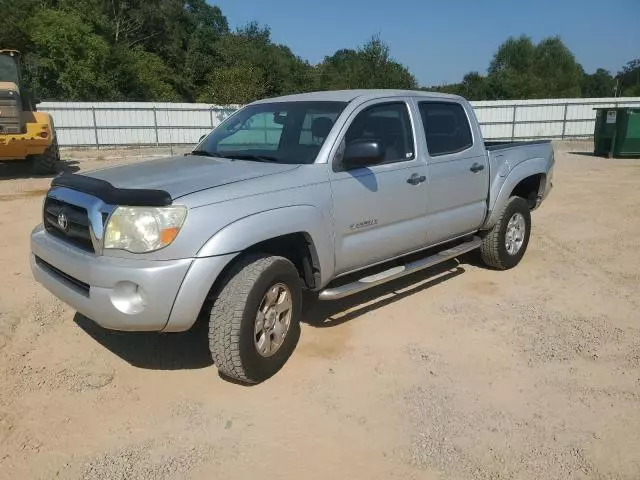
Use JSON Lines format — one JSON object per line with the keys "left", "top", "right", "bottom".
{"left": 480, "top": 197, "right": 531, "bottom": 270}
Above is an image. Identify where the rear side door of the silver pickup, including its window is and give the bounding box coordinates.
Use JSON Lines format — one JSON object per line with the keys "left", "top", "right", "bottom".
{"left": 418, "top": 100, "right": 489, "bottom": 244}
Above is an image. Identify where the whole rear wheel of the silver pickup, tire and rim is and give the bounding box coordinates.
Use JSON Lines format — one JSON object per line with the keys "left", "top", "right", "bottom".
{"left": 480, "top": 197, "right": 531, "bottom": 270}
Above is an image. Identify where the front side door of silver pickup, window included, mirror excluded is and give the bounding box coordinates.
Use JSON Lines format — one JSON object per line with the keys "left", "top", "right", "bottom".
{"left": 330, "top": 98, "right": 427, "bottom": 274}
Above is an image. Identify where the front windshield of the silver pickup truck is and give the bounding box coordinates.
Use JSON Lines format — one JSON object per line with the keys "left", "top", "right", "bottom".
{"left": 193, "top": 102, "right": 347, "bottom": 164}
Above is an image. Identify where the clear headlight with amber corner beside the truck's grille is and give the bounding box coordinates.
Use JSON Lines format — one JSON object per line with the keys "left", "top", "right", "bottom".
{"left": 104, "top": 205, "right": 187, "bottom": 253}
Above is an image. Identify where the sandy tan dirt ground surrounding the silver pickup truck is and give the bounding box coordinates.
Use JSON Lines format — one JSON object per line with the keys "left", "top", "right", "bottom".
{"left": 0, "top": 142, "right": 640, "bottom": 480}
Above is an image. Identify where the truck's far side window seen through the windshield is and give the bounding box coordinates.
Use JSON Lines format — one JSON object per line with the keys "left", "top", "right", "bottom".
{"left": 218, "top": 112, "right": 283, "bottom": 151}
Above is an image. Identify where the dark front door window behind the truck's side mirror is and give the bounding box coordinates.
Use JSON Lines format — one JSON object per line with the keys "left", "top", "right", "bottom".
{"left": 345, "top": 102, "right": 415, "bottom": 163}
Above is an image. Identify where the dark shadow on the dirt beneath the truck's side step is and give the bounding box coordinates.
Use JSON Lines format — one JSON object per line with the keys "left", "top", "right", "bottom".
{"left": 302, "top": 260, "right": 465, "bottom": 328}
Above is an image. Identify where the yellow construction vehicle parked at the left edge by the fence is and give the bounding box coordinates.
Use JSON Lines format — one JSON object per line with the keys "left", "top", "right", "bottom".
{"left": 0, "top": 50, "right": 60, "bottom": 175}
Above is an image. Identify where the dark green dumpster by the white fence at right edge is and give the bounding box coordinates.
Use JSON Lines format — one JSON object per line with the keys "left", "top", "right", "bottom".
{"left": 593, "top": 107, "right": 640, "bottom": 158}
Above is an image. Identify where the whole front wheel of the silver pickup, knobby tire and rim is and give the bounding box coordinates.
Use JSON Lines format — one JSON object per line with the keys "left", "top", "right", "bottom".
{"left": 209, "top": 255, "right": 302, "bottom": 383}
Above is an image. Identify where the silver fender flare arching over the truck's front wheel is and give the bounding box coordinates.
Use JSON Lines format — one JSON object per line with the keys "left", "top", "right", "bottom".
{"left": 196, "top": 205, "right": 335, "bottom": 285}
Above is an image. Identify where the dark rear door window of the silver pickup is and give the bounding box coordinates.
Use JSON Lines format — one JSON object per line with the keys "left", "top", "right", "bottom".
{"left": 419, "top": 102, "right": 473, "bottom": 157}
